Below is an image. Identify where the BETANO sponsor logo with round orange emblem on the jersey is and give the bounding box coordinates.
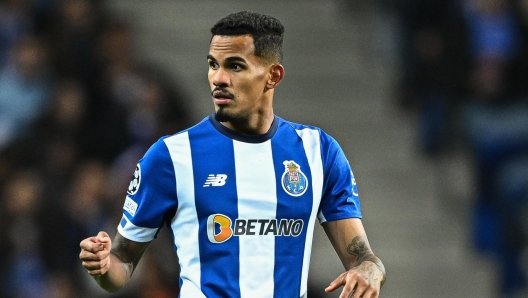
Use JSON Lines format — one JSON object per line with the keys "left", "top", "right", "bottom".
{"left": 207, "top": 214, "right": 304, "bottom": 243}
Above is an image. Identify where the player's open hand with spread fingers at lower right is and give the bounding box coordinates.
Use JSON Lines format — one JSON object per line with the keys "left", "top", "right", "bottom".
{"left": 325, "top": 261, "right": 383, "bottom": 298}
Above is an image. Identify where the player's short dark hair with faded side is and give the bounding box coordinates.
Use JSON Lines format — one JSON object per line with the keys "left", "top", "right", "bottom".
{"left": 211, "top": 11, "right": 284, "bottom": 63}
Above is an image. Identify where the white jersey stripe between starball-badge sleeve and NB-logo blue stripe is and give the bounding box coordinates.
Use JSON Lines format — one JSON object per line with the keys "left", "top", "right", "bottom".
{"left": 164, "top": 132, "right": 205, "bottom": 298}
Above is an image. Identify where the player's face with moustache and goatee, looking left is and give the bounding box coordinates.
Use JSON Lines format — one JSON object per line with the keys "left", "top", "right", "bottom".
{"left": 207, "top": 35, "right": 271, "bottom": 122}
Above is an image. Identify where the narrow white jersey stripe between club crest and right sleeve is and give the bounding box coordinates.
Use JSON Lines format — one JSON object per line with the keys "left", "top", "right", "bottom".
{"left": 297, "top": 129, "right": 323, "bottom": 296}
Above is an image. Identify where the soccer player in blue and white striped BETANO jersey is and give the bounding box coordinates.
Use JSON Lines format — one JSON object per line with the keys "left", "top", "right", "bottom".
{"left": 80, "top": 11, "right": 385, "bottom": 298}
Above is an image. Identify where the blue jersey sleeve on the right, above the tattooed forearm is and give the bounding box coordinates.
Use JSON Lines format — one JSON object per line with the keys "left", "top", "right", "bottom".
{"left": 318, "top": 135, "right": 362, "bottom": 224}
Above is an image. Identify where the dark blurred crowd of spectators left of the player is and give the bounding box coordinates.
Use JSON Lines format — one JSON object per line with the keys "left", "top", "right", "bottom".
{"left": 0, "top": 0, "right": 190, "bottom": 298}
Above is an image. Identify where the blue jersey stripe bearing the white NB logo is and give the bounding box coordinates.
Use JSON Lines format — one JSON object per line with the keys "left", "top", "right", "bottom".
{"left": 189, "top": 122, "right": 240, "bottom": 297}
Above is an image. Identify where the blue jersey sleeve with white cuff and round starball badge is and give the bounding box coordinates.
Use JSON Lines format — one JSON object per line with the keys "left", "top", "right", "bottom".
{"left": 117, "top": 140, "right": 177, "bottom": 242}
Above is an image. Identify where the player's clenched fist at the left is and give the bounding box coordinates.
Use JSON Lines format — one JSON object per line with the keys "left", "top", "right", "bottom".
{"left": 79, "top": 232, "right": 112, "bottom": 276}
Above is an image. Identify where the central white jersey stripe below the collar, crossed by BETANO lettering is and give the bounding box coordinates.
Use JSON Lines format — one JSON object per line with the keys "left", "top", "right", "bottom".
{"left": 233, "top": 140, "right": 277, "bottom": 297}
